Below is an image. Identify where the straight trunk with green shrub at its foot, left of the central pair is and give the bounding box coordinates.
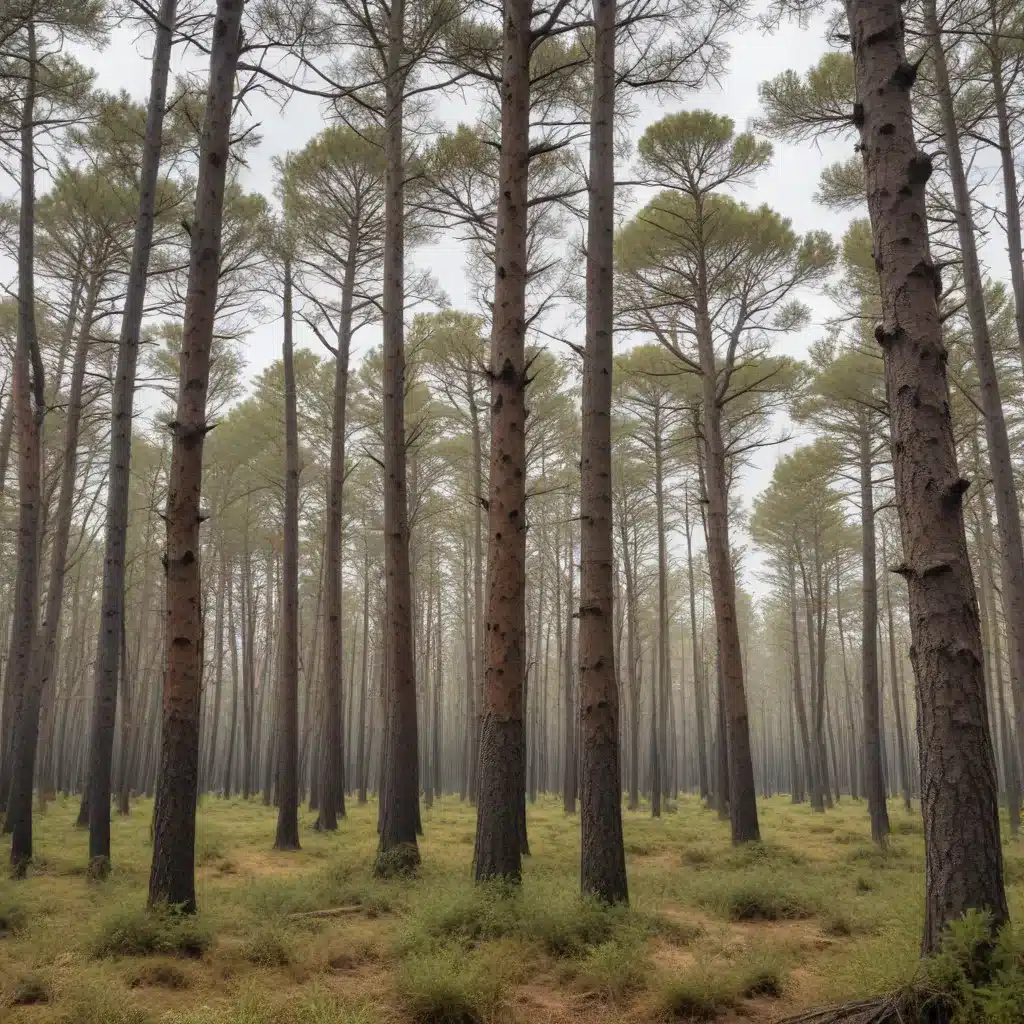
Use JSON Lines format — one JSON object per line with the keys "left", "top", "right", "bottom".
{"left": 377, "top": 0, "right": 420, "bottom": 871}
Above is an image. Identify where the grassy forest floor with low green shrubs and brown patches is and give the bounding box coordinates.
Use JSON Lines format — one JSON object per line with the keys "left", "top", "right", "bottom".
{"left": 0, "top": 797, "right": 1024, "bottom": 1024}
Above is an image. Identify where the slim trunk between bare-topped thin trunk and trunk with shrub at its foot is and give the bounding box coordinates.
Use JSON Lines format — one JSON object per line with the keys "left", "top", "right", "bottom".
{"left": 316, "top": 217, "right": 358, "bottom": 831}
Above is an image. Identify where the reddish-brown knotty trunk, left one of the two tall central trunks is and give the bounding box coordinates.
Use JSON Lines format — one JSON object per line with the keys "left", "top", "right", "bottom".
{"left": 474, "top": 0, "right": 532, "bottom": 881}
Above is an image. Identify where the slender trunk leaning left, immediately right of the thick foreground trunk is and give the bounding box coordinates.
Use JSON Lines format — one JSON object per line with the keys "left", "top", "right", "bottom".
{"left": 924, "top": 0, "right": 1024, "bottom": 790}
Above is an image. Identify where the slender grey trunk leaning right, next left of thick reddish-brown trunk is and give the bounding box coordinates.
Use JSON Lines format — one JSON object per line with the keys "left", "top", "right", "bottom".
{"left": 88, "top": 0, "right": 177, "bottom": 870}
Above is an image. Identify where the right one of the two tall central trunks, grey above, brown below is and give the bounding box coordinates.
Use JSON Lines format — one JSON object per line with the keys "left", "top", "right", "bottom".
{"left": 580, "top": 0, "right": 629, "bottom": 903}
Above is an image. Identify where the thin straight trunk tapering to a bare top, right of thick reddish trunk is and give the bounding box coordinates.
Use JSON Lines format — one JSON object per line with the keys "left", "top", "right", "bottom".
{"left": 267, "top": 259, "right": 299, "bottom": 850}
